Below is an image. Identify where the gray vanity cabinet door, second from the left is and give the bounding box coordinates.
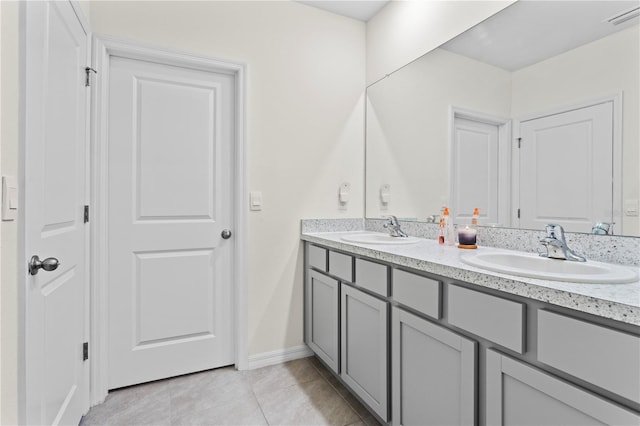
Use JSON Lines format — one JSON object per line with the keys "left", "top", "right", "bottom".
{"left": 341, "top": 284, "right": 389, "bottom": 421}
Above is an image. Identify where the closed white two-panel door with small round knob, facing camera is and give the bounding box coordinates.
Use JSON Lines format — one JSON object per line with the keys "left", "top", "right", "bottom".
{"left": 108, "top": 56, "right": 235, "bottom": 389}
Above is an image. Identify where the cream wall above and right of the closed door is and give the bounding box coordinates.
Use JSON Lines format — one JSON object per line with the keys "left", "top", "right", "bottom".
{"left": 90, "top": 1, "right": 365, "bottom": 355}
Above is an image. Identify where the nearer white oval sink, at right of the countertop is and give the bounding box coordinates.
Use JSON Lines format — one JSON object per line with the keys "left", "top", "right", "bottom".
{"left": 460, "top": 253, "right": 638, "bottom": 284}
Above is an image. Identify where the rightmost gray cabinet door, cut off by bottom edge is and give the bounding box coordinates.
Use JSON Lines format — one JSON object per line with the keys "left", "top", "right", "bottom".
{"left": 486, "top": 350, "right": 640, "bottom": 426}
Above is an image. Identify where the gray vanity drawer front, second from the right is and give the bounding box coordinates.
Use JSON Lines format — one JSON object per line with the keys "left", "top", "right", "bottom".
{"left": 447, "top": 285, "right": 525, "bottom": 354}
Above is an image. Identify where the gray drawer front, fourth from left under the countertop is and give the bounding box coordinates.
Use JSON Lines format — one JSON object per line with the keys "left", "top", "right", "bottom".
{"left": 392, "top": 269, "right": 441, "bottom": 319}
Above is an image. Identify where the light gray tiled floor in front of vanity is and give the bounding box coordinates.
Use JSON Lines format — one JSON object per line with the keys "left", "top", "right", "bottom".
{"left": 80, "top": 357, "right": 379, "bottom": 426}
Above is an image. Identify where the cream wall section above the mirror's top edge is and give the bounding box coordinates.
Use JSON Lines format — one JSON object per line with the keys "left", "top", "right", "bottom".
{"left": 367, "top": 0, "right": 515, "bottom": 85}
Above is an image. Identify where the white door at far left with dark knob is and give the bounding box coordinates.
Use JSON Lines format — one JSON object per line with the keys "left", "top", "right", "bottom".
{"left": 20, "top": 1, "right": 89, "bottom": 425}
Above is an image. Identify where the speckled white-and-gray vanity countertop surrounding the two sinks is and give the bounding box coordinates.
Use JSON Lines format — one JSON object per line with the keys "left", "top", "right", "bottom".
{"left": 301, "top": 231, "right": 640, "bottom": 326}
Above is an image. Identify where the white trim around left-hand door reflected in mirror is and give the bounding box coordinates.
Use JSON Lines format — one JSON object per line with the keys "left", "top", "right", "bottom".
{"left": 449, "top": 105, "right": 511, "bottom": 227}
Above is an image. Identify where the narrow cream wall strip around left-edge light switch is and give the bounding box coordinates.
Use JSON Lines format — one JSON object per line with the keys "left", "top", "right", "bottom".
{"left": 0, "top": 1, "right": 18, "bottom": 425}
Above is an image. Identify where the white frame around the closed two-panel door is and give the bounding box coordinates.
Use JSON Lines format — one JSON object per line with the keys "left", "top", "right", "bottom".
{"left": 90, "top": 34, "right": 248, "bottom": 406}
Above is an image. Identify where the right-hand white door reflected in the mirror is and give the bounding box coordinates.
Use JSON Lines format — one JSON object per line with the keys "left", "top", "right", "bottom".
{"left": 519, "top": 101, "right": 615, "bottom": 232}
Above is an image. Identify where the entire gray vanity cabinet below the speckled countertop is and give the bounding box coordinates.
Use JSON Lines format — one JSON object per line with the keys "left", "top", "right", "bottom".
{"left": 305, "top": 244, "right": 640, "bottom": 426}
